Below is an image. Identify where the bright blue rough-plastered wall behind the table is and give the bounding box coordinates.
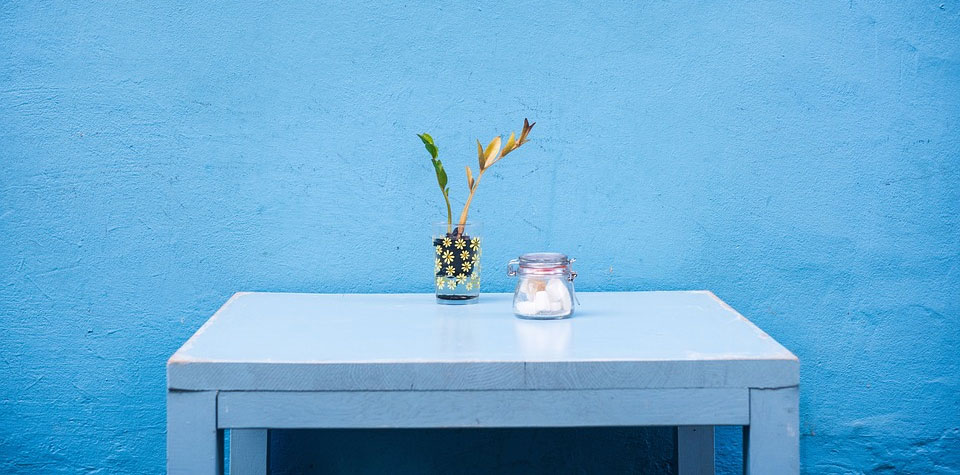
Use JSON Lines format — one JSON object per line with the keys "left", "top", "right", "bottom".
{"left": 0, "top": 0, "right": 960, "bottom": 473}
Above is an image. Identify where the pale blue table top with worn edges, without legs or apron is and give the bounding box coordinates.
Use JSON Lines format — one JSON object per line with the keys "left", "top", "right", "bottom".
{"left": 168, "top": 291, "right": 799, "bottom": 390}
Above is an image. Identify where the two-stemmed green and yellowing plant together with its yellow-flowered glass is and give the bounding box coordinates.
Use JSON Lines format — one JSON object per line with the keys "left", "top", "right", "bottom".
{"left": 417, "top": 119, "right": 536, "bottom": 304}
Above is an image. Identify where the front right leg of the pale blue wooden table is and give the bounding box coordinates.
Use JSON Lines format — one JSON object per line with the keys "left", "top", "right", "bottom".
{"left": 743, "top": 386, "right": 800, "bottom": 475}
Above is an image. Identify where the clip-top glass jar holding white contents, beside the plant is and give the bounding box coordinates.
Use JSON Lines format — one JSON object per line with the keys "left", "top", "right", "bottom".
{"left": 507, "top": 252, "right": 577, "bottom": 320}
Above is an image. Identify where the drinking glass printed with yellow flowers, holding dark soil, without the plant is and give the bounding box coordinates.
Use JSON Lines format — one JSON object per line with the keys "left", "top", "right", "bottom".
{"left": 433, "top": 222, "right": 481, "bottom": 305}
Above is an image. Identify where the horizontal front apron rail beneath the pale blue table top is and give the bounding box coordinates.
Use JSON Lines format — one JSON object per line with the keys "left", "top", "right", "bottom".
{"left": 217, "top": 388, "right": 750, "bottom": 429}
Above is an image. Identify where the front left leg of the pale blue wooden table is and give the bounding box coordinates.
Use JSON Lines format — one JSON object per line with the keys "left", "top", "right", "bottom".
{"left": 167, "top": 391, "right": 223, "bottom": 475}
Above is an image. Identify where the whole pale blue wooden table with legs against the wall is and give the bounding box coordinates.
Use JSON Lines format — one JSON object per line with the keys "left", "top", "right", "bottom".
{"left": 167, "top": 291, "right": 799, "bottom": 475}
